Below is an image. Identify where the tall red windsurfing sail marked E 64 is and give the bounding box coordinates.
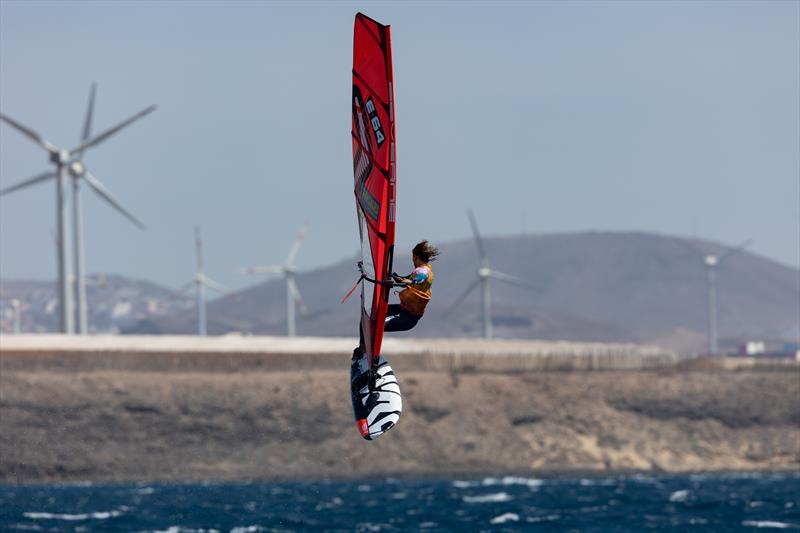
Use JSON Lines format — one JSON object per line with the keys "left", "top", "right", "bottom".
{"left": 351, "top": 13, "right": 396, "bottom": 357}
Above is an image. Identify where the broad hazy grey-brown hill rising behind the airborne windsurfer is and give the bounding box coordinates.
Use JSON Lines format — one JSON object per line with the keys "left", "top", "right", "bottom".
{"left": 163, "top": 233, "right": 800, "bottom": 350}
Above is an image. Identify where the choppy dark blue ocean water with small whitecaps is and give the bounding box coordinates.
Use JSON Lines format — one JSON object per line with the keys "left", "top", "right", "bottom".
{"left": 0, "top": 472, "right": 800, "bottom": 533}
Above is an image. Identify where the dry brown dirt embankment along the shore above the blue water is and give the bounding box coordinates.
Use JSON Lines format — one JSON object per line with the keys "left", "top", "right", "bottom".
{"left": 0, "top": 356, "right": 800, "bottom": 483}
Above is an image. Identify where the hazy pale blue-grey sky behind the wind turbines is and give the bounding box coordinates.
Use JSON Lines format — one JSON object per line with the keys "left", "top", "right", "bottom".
{"left": 0, "top": 0, "right": 800, "bottom": 287}
